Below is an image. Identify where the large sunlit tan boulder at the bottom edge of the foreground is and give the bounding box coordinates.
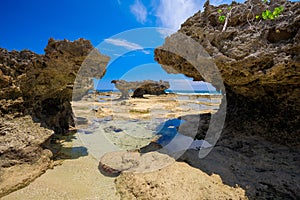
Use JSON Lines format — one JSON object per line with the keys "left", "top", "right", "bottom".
{"left": 116, "top": 162, "right": 248, "bottom": 200}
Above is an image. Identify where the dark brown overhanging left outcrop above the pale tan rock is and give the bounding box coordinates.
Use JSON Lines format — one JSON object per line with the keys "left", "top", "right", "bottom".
{"left": 0, "top": 39, "right": 109, "bottom": 133}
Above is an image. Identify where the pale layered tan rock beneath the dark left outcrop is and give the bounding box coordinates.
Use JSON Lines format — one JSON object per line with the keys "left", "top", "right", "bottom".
{"left": 0, "top": 116, "right": 53, "bottom": 197}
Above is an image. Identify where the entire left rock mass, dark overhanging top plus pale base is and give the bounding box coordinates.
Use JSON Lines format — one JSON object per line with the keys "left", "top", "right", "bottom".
{"left": 0, "top": 39, "right": 109, "bottom": 197}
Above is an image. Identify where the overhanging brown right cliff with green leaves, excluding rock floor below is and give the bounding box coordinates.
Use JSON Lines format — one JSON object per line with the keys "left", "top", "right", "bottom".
{"left": 155, "top": 0, "right": 300, "bottom": 144}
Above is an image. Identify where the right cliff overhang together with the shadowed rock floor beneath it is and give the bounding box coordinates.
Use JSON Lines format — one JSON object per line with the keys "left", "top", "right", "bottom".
{"left": 155, "top": 0, "right": 300, "bottom": 199}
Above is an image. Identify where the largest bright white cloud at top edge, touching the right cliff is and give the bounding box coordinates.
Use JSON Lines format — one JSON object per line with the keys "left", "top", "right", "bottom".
{"left": 155, "top": 0, "right": 204, "bottom": 31}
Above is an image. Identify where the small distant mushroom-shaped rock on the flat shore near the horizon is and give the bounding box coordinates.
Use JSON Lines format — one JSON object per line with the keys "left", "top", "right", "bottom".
{"left": 111, "top": 80, "right": 170, "bottom": 99}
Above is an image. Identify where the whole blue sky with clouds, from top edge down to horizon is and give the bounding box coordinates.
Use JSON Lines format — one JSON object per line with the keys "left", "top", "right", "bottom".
{"left": 0, "top": 0, "right": 246, "bottom": 92}
